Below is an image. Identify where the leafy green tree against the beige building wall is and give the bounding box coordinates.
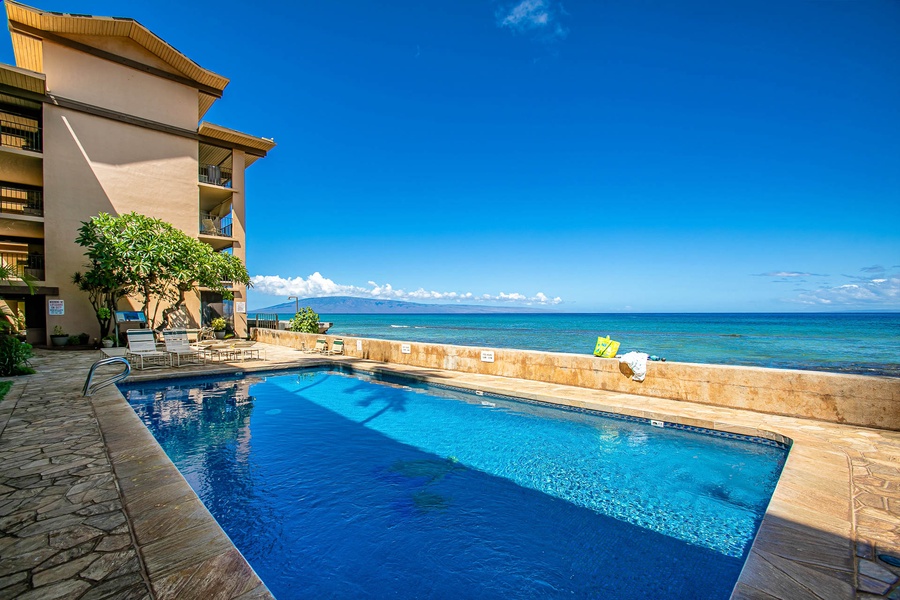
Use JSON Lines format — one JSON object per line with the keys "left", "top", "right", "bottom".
{"left": 75, "top": 212, "right": 250, "bottom": 327}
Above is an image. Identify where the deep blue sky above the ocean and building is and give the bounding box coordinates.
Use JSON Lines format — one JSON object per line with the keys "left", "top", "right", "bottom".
{"left": 0, "top": 0, "right": 900, "bottom": 312}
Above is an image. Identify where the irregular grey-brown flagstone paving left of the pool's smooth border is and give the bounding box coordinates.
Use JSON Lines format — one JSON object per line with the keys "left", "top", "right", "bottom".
{"left": 0, "top": 353, "right": 151, "bottom": 600}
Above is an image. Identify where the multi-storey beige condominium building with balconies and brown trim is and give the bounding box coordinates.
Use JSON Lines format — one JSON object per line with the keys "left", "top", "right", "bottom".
{"left": 0, "top": 0, "right": 275, "bottom": 344}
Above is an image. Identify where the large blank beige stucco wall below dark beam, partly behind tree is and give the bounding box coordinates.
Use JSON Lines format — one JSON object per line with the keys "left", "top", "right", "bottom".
{"left": 44, "top": 88, "right": 199, "bottom": 337}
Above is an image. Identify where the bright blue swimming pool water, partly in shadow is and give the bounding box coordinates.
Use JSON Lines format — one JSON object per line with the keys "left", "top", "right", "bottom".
{"left": 122, "top": 370, "right": 787, "bottom": 600}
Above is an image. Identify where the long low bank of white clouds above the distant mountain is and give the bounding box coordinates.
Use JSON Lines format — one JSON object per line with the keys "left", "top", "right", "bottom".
{"left": 252, "top": 272, "right": 563, "bottom": 306}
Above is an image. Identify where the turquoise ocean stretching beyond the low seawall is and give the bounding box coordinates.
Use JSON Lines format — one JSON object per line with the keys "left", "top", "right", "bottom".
{"left": 251, "top": 313, "right": 900, "bottom": 377}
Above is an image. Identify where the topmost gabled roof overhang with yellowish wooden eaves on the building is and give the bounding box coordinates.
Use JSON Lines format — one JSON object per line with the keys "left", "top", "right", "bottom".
{"left": 6, "top": 0, "right": 228, "bottom": 116}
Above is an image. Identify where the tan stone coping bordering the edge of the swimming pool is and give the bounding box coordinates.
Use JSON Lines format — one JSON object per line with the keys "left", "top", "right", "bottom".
{"left": 82, "top": 356, "right": 900, "bottom": 600}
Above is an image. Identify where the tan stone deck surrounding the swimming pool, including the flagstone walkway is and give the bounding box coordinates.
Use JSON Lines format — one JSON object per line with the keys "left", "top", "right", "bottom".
{"left": 0, "top": 346, "right": 900, "bottom": 600}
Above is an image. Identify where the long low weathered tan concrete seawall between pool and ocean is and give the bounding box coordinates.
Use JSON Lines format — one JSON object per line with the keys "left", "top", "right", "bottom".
{"left": 252, "top": 329, "right": 900, "bottom": 430}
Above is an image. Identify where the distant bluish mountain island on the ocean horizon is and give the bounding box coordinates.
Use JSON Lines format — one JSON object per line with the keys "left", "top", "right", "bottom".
{"left": 248, "top": 296, "right": 546, "bottom": 315}
